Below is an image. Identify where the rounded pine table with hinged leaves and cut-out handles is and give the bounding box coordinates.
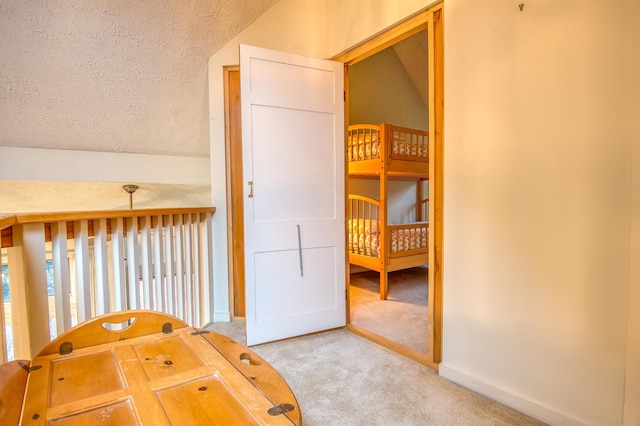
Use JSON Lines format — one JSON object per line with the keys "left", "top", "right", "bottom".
{"left": 15, "top": 311, "right": 301, "bottom": 426}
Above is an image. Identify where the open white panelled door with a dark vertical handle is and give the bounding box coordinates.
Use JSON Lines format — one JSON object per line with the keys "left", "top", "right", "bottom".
{"left": 240, "top": 45, "right": 346, "bottom": 345}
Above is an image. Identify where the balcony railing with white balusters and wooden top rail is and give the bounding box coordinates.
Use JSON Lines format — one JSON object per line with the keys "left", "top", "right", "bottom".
{"left": 0, "top": 207, "right": 215, "bottom": 362}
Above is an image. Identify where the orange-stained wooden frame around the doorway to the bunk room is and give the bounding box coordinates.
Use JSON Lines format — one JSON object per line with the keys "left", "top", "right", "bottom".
{"left": 331, "top": 2, "right": 444, "bottom": 369}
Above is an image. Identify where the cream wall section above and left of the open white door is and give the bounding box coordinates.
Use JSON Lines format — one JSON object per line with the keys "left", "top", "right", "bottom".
{"left": 209, "top": 0, "right": 433, "bottom": 321}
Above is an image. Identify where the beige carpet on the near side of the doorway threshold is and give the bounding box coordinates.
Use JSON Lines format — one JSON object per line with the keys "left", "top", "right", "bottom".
{"left": 208, "top": 319, "right": 541, "bottom": 426}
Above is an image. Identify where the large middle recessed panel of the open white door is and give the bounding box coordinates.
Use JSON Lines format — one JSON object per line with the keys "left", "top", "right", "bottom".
{"left": 251, "top": 106, "right": 337, "bottom": 222}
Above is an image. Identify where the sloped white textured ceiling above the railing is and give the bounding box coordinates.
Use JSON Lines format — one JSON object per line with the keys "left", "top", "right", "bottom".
{"left": 0, "top": 0, "right": 277, "bottom": 157}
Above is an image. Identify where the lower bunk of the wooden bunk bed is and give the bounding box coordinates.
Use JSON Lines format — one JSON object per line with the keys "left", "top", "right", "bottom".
{"left": 347, "top": 195, "right": 429, "bottom": 300}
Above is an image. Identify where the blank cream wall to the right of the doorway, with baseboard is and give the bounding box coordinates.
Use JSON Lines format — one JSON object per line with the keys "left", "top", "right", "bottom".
{"left": 440, "top": 0, "right": 640, "bottom": 425}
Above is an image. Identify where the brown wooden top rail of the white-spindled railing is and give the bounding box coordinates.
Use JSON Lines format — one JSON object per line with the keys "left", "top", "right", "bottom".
{"left": 0, "top": 207, "right": 216, "bottom": 229}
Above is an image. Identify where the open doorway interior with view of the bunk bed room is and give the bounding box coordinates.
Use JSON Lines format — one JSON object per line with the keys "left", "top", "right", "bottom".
{"left": 347, "top": 30, "right": 429, "bottom": 356}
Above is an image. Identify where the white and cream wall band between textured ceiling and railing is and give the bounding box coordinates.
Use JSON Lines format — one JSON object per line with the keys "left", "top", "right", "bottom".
{"left": 0, "top": 147, "right": 211, "bottom": 214}
